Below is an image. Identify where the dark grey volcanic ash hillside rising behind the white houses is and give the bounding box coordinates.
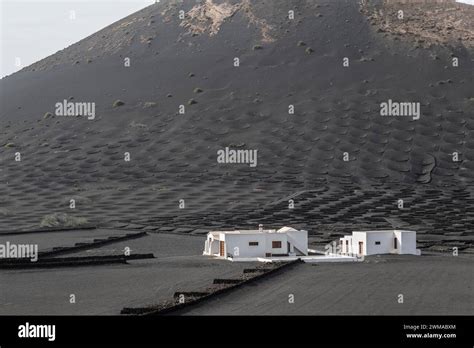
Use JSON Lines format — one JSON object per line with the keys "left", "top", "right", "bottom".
{"left": 0, "top": 0, "right": 474, "bottom": 250}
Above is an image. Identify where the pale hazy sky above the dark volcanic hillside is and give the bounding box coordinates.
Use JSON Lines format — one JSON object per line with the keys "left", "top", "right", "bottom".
{"left": 0, "top": 0, "right": 474, "bottom": 77}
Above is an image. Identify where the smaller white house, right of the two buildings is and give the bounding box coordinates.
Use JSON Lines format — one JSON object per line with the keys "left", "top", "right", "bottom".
{"left": 339, "top": 230, "right": 421, "bottom": 255}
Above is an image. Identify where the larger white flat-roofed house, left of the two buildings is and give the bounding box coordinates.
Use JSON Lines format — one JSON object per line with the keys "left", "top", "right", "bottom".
{"left": 203, "top": 227, "right": 308, "bottom": 261}
